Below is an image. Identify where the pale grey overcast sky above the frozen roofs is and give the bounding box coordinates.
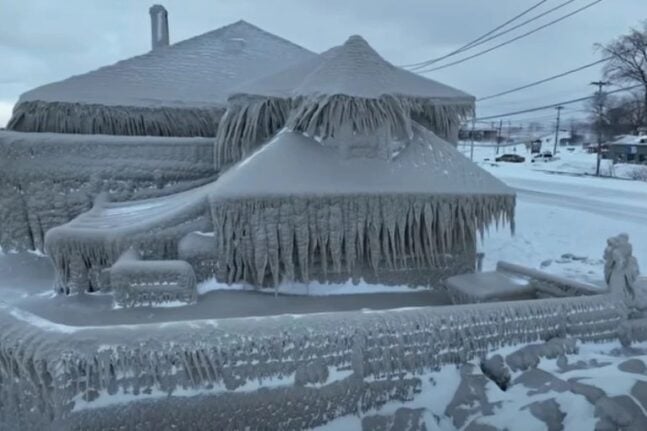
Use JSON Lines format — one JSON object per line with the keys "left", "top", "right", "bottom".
{"left": 0, "top": 0, "right": 647, "bottom": 126}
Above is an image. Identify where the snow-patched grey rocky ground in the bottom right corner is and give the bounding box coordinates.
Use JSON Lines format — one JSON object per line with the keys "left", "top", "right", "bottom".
{"left": 316, "top": 343, "right": 647, "bottom": 431}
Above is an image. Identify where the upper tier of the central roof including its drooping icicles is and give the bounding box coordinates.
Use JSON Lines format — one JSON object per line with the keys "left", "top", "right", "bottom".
{"left": 216, "top": 36, "right": 474, "bottom": 167}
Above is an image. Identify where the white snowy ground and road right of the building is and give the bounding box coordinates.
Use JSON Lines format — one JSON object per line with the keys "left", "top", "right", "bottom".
{"left": 466, "top": 145, "right": 647, "bottom": 288}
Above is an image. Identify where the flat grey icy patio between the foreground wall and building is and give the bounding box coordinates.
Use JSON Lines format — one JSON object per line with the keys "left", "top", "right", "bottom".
{"left": 0, "top": 253, "right": 451, "bottom": 326}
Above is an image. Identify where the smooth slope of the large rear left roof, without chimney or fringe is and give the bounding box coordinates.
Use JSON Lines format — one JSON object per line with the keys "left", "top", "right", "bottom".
{"left": 18, "top": 20, "right": 316, "bottom": 108}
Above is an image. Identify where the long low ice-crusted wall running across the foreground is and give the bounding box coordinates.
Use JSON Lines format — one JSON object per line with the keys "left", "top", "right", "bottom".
{"left": 0, "top": 294, "right": 627, "bottom": 429}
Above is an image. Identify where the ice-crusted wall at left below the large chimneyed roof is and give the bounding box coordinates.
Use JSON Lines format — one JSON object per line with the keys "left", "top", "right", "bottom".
{"left": 0, "top": 131, "right": 216, "bottom": 250}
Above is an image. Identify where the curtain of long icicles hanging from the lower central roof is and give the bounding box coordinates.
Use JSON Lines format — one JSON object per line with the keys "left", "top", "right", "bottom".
{"left": 211, "top": 195, "right": 514, "bottom": 284}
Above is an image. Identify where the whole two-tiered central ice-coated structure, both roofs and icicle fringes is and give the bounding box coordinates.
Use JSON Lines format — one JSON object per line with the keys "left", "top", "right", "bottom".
{"left": 209, "top": 36, "right": 515, "bottom": 285}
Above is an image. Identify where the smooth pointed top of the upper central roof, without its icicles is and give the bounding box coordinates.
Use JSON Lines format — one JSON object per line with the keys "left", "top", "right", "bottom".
{"left": 230, "top": 35, "right": 474, "bottom": 104}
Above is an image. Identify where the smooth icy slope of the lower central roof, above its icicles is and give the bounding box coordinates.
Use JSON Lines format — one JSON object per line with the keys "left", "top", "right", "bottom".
{"left": 210, "top": 126, "right": 514, "bottom": 199}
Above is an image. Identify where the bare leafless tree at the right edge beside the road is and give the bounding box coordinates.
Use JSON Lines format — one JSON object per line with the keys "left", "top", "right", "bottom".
{"left": 596, "top": 21, "right": 647, "bottom": 125}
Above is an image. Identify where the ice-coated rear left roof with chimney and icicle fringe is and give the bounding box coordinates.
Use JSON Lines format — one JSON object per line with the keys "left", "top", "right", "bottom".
{"left": 7, "top": 5, "right": 315, "bottom": 136}
